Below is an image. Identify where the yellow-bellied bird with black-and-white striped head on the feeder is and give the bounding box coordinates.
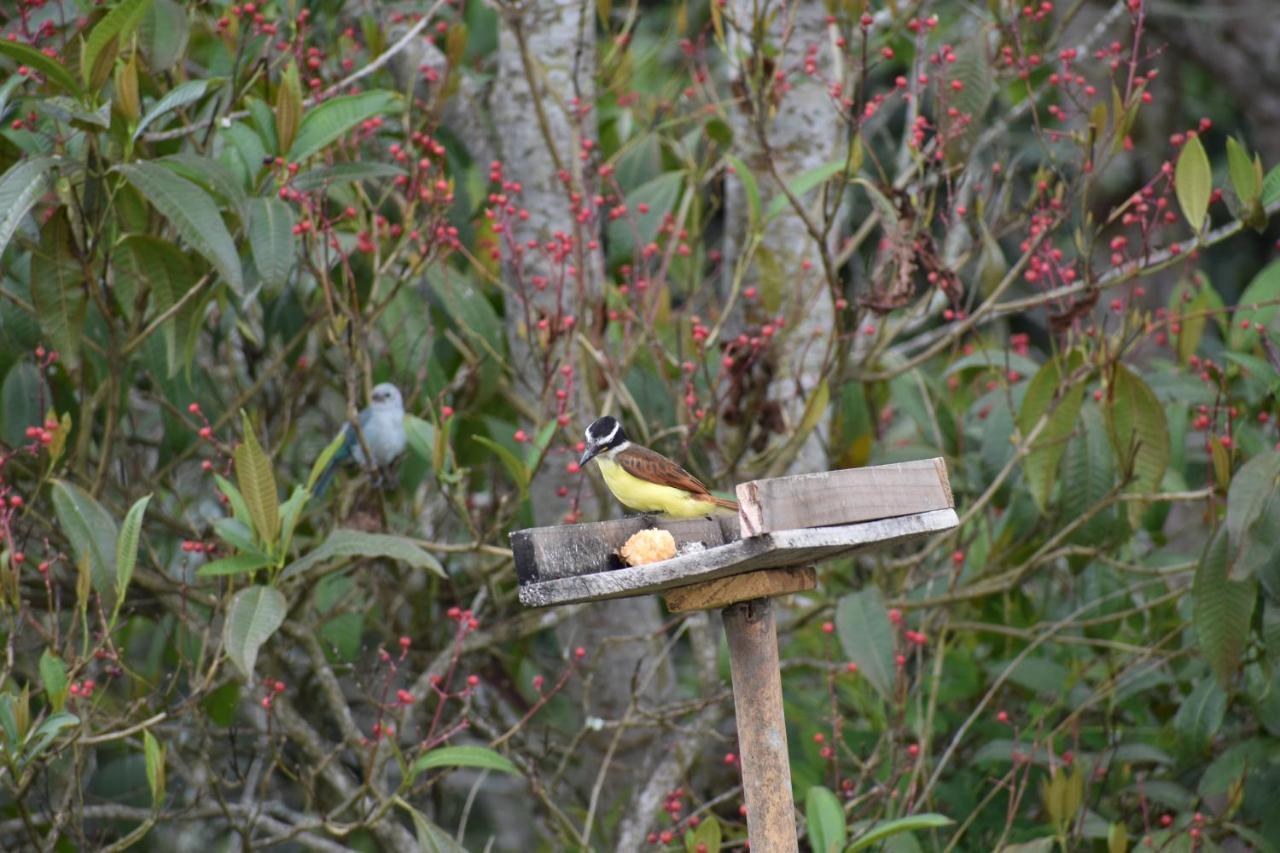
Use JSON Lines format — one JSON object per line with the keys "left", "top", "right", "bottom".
{"left": 579, "top": 415, "right": 737, "bottom": 519}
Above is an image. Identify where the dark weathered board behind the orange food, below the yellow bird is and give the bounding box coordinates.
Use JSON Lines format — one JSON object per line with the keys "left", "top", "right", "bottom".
{"left": 511, "top": 515, "right": 739, "bottom": 584}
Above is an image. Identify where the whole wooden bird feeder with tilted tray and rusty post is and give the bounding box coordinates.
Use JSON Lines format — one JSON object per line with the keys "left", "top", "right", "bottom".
{"left": 511, "top": 459, "right": 959, "bottom": 853}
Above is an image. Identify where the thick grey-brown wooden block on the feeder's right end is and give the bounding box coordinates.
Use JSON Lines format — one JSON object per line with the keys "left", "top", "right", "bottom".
{"left": 737, "top": 459, "right": 955, "bottom": 537}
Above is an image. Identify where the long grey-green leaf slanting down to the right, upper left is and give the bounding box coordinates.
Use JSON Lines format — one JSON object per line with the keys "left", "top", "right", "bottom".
{"left": 115, "top": 161, "right": 244, "bottom": 293}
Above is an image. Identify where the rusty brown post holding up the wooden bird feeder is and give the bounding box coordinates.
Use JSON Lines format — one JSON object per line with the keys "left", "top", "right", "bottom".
{"left": 722, "top": 598, "right": 800, "bottom": 853}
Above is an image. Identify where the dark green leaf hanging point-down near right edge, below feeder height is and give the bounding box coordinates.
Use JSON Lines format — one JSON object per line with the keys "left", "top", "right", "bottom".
{"left": 1192, "top": 526, "right": 1257, "bottom": 689}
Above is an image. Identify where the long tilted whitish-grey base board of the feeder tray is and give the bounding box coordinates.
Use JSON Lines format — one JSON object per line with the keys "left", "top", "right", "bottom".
{"left": 520, "top": 508, "right": 959, "bottom": 607}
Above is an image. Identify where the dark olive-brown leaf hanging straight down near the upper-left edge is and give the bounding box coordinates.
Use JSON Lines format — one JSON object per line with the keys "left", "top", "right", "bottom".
{"left": 31, "top": 209, "right": 87, "bottom": 369}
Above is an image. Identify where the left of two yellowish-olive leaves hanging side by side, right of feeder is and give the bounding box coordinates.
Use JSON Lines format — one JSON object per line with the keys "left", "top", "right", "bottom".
{"left": 1018, "top": 352, "right": 1084, "bottom": 512}
